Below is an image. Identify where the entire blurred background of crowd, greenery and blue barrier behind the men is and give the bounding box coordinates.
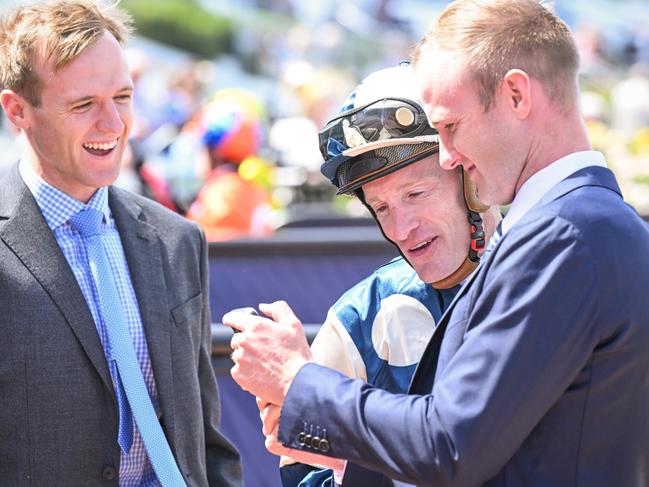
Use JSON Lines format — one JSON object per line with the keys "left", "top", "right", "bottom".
{"left": 0, "top": 0, "right": 649, "bottom": 487}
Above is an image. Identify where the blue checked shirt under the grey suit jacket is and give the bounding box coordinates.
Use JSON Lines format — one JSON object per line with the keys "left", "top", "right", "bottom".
{"left": 20, "top": 159, "right": 160, "bottom": 487}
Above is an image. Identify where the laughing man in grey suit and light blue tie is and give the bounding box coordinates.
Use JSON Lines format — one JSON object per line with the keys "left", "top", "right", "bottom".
{"left": 0, "top": 1, "right": 241, "bottom": 486}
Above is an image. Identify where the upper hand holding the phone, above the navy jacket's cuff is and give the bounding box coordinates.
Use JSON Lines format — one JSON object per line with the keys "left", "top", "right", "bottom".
{"left": 223, "top": 301, "right": 312, "bottom": 406}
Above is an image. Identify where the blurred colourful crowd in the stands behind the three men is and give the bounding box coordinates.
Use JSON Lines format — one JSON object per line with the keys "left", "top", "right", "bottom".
{"left": 0, "top": 0, "right": 649, "bottom": 241}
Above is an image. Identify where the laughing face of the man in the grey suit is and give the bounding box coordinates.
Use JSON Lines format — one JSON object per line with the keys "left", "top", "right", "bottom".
{"left": 22, "top": 32, "right": 133, "bottom": 202}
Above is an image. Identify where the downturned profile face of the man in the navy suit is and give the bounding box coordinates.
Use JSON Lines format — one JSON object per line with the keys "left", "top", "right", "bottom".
{"left": 417, "top": 49, "right": 527, "bottom": 205}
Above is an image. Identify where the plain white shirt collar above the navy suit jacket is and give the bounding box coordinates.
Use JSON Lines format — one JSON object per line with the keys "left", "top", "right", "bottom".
{"left": 502, "top": 151, "right": 607, "bottom": 235}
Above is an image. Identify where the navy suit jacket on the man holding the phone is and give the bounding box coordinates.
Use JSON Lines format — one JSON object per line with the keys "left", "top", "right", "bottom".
{"left": 279, "top": 167, "right": 649, "bottom": 487}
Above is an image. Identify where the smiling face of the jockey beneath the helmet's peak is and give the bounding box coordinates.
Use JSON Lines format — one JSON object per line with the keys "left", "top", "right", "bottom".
{"left": 363, "top": 154, "right": 469, "bottom": 283}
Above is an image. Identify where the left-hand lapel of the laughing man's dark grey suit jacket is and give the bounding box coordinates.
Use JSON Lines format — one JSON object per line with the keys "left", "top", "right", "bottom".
{"left": 0, "top": 166, "right": 112, "bottom": 391}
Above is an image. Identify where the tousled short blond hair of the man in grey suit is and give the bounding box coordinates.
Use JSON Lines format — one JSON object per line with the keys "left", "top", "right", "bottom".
{"left": 0, "top": 0, "right": 132, "bottom": 106}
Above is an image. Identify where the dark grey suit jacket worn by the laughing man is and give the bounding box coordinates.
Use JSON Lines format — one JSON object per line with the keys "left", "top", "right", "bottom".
{"left": 0, "top": 166, "right": 241, "bottom": 486}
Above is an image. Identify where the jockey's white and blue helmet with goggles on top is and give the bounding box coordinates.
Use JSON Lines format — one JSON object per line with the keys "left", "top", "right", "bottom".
{"left": 319, "top": 63, "right": 439, "bottom": 194}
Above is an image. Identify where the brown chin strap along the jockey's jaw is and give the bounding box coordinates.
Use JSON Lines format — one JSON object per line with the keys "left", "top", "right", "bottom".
{"left": 430, "top": 166, "right": 489, "bottom": 289}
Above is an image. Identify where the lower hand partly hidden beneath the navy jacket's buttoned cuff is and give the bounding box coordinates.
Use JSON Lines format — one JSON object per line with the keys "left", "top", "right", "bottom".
{"left": 257, "top": 398, "right": 345, "bottom": 472}
